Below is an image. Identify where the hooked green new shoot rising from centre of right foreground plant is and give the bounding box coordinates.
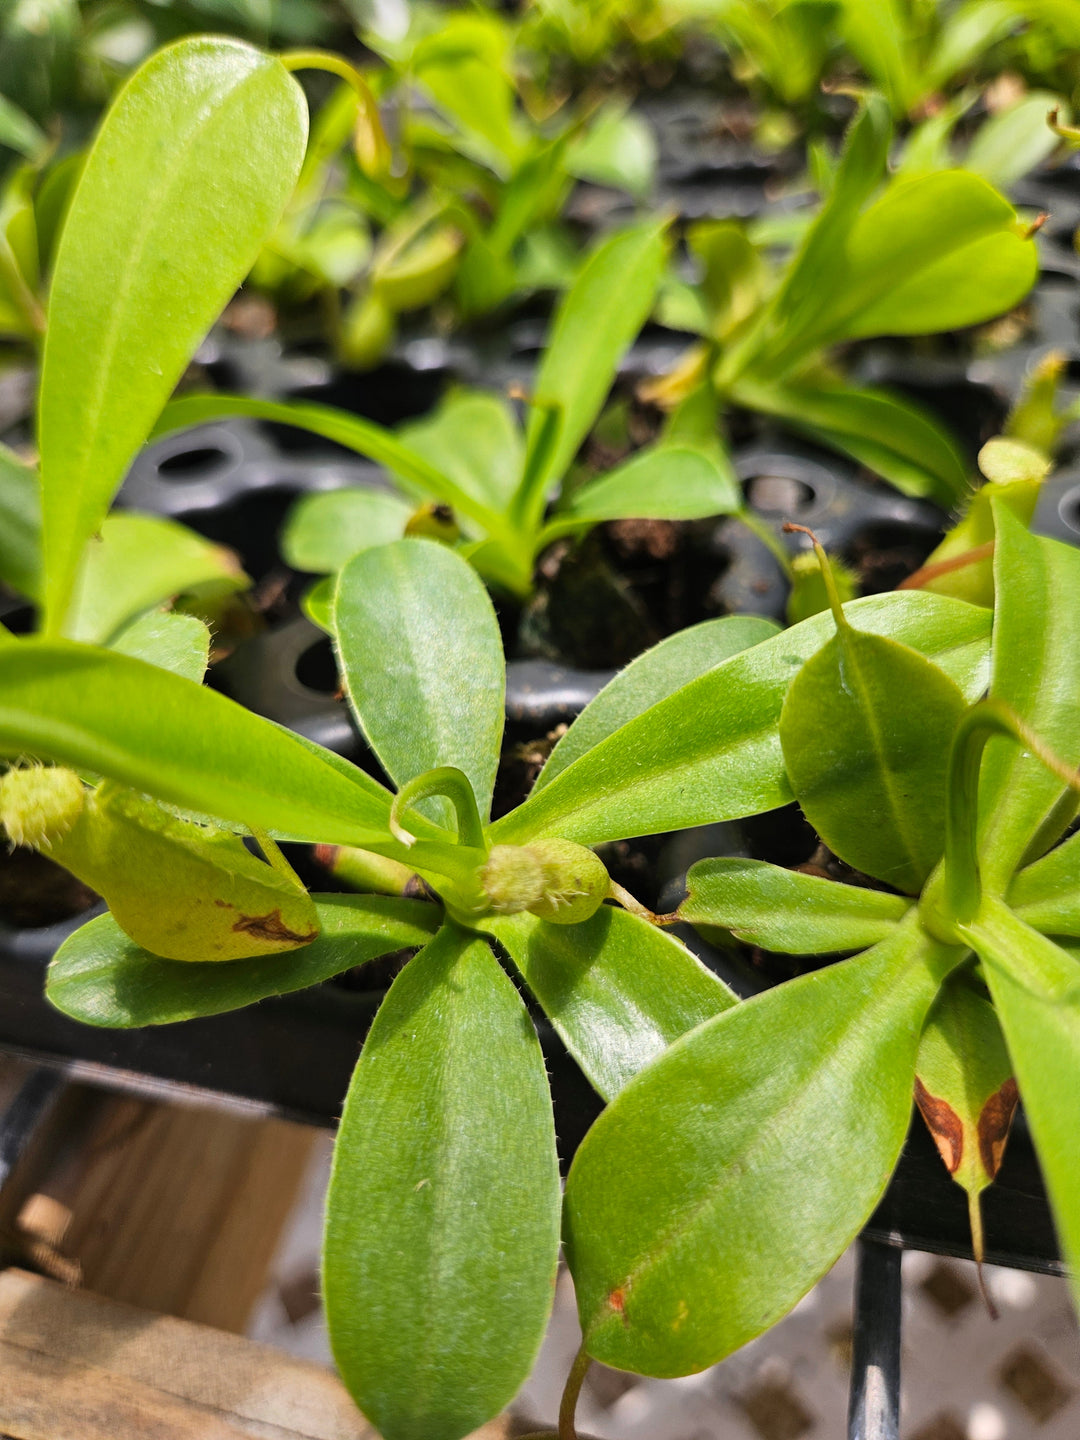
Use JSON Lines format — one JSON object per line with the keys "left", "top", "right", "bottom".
{"left": 945, "top": 700, "right": 1080, "bottom": 924}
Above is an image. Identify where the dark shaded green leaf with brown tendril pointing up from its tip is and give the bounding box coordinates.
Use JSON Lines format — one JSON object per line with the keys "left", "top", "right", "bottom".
{"left": 780, "top": 596, "right": 968, "bottom": 894}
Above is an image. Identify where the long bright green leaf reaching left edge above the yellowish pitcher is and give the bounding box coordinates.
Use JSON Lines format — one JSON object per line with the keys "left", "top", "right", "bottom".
{"left": 0, "top": 639, "right": 390, "bottom": 845}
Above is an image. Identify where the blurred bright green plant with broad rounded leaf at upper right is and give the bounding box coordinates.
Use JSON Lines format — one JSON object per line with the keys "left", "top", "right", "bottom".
{"left": 642, "top": 94, "right": 1038, "bottom": 508}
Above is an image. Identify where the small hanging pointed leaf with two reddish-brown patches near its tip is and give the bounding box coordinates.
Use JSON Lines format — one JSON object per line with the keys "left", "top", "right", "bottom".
{"left": 914, "top": 971, "right": 1017, "bottom": 1312}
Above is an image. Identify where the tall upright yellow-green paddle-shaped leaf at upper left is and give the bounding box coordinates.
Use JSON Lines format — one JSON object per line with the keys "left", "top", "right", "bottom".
{"left": 37, "top": 37, "right": 307, "bottom": 632}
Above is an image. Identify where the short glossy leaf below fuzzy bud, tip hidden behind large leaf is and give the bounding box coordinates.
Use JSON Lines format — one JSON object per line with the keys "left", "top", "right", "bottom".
{"left": 480, "top": 906, "right": 736, "bottom": 1100}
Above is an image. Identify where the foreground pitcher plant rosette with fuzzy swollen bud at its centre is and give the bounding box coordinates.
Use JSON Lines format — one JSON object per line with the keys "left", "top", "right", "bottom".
{"left": 0, "top": 540, "right": 989, "bottom": 1440}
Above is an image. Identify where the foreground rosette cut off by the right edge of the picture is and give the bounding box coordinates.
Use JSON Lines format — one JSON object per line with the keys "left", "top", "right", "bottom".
{"left": 564, "top": 500, "right": 1080, "bottom": 1375}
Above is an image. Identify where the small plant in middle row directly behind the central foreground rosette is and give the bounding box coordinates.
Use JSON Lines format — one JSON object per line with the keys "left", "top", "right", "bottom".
{"left": 157, "top": 210, "right": 776, "bottom": 618}
